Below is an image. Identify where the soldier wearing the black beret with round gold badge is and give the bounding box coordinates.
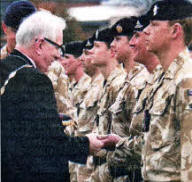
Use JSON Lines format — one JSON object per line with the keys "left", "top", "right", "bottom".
{"left": 108, "top": 17, "right": 149, "bottom": 182}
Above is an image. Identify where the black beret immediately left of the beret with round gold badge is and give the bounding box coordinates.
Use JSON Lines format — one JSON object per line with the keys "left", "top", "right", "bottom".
{"left": 94, "top": 28, "right": 114, "bottom": 44}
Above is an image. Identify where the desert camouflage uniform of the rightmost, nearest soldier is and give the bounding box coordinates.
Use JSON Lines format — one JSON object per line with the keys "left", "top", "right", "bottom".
{"left": 142, "top": 49, "right": 192, "bottom": 182}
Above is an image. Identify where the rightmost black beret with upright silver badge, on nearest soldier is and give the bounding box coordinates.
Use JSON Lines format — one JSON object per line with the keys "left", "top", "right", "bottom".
{"left": 147, "top": 0, "right": 192, "bottom": 21}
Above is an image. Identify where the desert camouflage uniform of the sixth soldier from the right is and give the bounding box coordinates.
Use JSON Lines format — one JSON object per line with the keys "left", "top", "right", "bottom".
{"left": 65, "top": 74, "right": 91, "bottom": 182}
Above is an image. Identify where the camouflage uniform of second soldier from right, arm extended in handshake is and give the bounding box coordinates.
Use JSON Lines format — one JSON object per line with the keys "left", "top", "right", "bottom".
{"left": 107, "top": 65, "right": 163, "bottom": 182}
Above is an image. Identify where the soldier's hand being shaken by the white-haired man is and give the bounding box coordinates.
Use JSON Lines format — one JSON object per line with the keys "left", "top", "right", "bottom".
{"left": 97, "top": 134, "right": 121, "bottom": 147}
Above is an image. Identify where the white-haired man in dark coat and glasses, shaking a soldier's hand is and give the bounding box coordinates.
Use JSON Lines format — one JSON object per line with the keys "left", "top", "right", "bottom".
{"left": 0, "top": 11, "right": 103, "bottom": 182}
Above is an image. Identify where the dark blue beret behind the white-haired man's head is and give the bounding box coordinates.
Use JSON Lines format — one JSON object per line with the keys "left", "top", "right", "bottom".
{"left": 3, "top": 1, "right": 36, "bottom": 30}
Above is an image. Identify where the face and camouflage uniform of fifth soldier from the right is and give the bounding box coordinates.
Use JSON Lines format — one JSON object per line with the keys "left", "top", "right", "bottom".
{"left": 76, "top": 42, "right": 104, "bottom": 182}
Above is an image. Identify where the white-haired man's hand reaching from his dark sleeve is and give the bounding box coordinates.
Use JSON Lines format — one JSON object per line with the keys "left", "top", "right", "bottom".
{"left": 86, "top": 133, "right": 104, "bottom": 154}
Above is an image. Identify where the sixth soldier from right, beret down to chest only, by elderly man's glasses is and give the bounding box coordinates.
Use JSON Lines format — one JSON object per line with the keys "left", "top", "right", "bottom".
{"left": 62, "top": 41, "right": 91, "bottom": 107}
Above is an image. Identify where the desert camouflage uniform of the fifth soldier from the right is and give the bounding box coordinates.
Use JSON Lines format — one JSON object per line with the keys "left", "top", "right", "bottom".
{"left": 76, "top": 74, "right": 104, "bottom": 182}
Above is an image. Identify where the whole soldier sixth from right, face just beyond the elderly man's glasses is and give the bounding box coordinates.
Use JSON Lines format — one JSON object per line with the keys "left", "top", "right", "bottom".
{"left": 61, "top": 41, "right": 91, "bottom": 182}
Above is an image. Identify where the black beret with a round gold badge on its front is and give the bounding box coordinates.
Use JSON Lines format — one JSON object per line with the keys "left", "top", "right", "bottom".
{"left": 111, "top": 17, "right": 138, "bottom": 36}
